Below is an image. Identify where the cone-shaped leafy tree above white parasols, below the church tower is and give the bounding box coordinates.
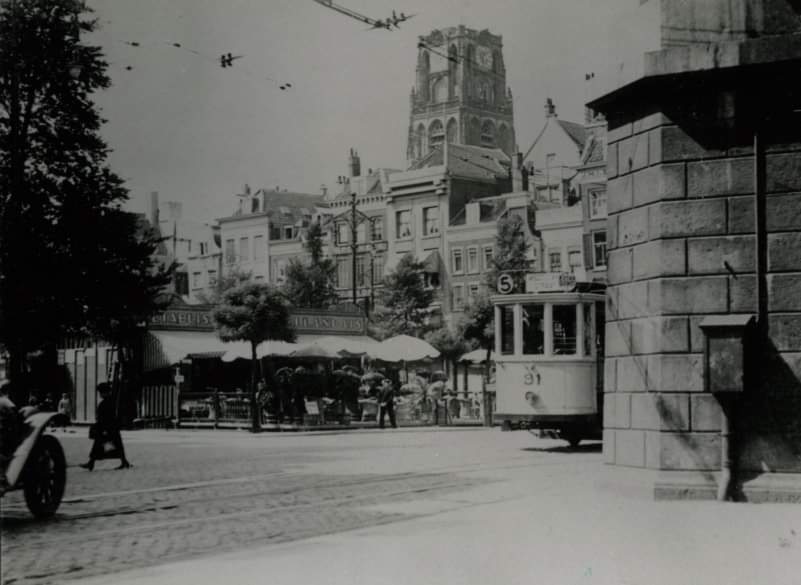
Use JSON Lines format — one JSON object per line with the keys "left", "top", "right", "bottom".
{"left": 377, "top": 254, "right": 434, "bottom": 336}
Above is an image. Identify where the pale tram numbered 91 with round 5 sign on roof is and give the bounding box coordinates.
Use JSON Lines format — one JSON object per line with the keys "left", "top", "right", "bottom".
{"left": 492, "top": 273, "right": 605, "bottom": 447}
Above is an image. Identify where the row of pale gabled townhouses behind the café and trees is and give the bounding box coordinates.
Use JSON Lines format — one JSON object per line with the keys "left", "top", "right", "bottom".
{"left": 152, "top": 100, "right": 606, "bottom": 320}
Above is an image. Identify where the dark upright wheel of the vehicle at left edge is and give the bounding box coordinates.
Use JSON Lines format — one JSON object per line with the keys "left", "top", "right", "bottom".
{"left": 23, "top": 435, "right": 67, "bottom": 518}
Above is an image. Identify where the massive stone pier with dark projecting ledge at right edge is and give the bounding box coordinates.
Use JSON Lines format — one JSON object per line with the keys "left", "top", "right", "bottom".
{"left": 590, "top": 0, "right": 801, "bottom": 501}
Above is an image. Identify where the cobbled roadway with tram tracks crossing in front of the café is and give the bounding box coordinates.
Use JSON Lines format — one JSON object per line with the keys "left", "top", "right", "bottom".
{"left": 1, "top": 429, "right": 600, "bottom": 584}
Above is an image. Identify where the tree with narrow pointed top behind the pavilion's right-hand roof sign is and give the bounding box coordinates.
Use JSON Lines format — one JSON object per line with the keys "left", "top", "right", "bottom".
{"left": 284, "top": 222, "right": 339, "bottom": 309}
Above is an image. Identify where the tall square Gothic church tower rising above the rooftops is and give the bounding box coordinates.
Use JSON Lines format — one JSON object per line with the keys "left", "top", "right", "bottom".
{"left": 406, "top": 25, "right": 516, "bottom": 164}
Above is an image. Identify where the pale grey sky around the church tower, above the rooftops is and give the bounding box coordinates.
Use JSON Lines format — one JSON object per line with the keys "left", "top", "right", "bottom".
{"left": 88, "top": 0, "right": 652, "bottom": 221}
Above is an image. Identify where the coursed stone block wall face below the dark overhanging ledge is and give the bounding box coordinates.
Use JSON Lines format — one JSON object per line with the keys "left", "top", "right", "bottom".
{"left": 604, "top": 108, "right": 801, "bottom": 474}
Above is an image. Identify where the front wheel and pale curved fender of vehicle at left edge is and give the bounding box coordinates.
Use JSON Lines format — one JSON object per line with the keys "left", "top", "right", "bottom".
{"left": 0, "top": 412, "right": 67, "bottom": 518}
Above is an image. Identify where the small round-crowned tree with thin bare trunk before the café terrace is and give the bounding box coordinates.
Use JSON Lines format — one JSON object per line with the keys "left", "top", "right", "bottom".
{"left": 213, "top": 282, "right": 295, "bottom": 433}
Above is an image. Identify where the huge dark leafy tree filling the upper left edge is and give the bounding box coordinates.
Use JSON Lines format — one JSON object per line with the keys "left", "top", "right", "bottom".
{"left": 0, "top": 0, "right": 169, "bottom": 388}
